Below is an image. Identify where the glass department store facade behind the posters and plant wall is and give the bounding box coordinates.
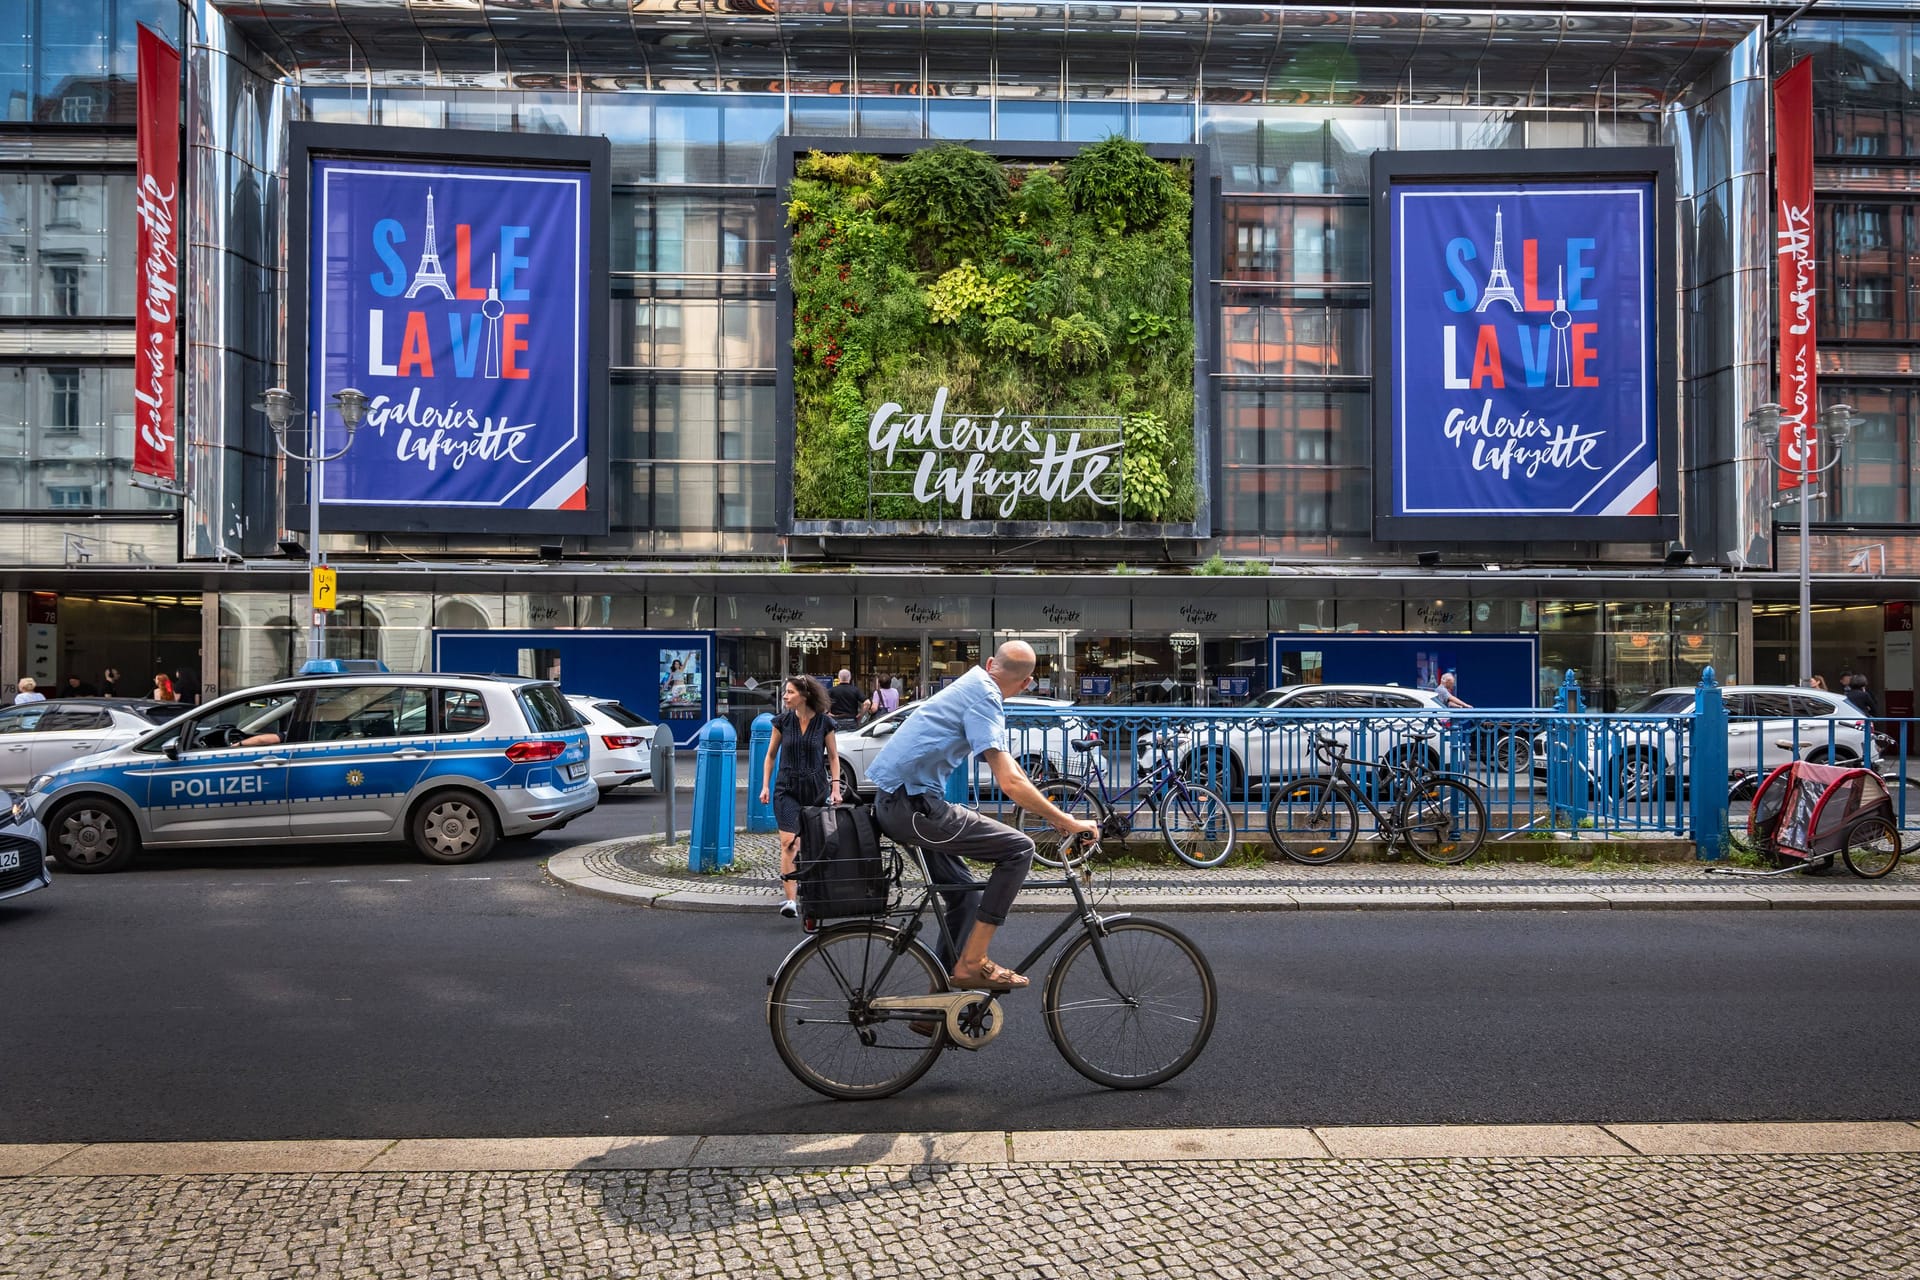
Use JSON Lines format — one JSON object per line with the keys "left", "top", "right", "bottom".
{"left": 0, "top": 0, "right": 1920, "bottom": 708}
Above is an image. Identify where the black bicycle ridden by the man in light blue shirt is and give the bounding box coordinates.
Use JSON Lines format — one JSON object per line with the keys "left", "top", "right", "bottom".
{"left": 766, "top": 832, "right": 1217, "bottom": 1100}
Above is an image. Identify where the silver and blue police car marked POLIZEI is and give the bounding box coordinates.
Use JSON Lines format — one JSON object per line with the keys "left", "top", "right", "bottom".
{"left": 31, "top": 672, "right": 599, "bottom": 871}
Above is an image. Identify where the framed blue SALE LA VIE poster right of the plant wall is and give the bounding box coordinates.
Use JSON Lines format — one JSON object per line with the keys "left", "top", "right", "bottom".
{"left": 1375, "top": 148, "right": 1678, "bottom": 541}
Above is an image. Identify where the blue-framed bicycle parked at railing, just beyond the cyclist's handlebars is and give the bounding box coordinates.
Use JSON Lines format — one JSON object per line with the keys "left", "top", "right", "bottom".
{"left": 1020, "top": 733, "right": 1240, "bottom": 867}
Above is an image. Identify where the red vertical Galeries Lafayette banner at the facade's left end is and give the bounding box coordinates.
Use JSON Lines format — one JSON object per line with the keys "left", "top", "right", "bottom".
{"left": 132, "top": 27, "right": 180, "bottom": 480}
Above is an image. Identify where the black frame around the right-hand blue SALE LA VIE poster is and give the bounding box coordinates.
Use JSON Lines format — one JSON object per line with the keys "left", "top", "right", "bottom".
{"left": 1369, "top": 146, "right": 1680, "bottom": 543}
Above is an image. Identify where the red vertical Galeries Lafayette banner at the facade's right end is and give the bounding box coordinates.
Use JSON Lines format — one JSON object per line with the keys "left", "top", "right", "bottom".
{"left": 1774, "top": 58, "right": 1820, "bottom": 489}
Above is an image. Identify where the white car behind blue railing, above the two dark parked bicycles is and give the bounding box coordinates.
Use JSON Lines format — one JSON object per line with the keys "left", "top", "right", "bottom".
{"left": 1135, "top": 685, "right": 1450, "bottom": 794}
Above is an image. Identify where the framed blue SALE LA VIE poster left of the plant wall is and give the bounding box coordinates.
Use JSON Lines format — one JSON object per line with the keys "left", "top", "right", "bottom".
{"left": 296, "top": 127, "right": 607, "bottom": 533}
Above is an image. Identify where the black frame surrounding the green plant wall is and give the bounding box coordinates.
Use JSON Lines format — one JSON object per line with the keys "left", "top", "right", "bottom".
{"left": 774, "top": 134, "right": 1221, "bottom": 545}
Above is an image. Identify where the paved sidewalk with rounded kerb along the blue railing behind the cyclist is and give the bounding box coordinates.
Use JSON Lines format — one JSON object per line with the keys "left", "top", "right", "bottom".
{"left": 547, "top": 831, "right": 1920, "bottom": 912}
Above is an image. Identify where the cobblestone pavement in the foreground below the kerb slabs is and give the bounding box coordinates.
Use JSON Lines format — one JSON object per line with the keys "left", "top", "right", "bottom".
{"left": 0, "top": 1155, "right": 1920, "bottom": 1280}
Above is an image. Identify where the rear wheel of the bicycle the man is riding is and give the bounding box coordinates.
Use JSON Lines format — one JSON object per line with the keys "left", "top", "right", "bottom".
{"left": 766, "top": 921, "right": 947, "bottom": 1102}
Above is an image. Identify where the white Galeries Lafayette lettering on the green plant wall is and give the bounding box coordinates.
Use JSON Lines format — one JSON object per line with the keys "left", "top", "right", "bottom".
{"left": 866, "top": 388, "right": 1119, "bottom": 520}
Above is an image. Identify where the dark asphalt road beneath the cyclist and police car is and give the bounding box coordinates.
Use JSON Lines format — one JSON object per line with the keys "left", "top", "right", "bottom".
{"left": 0, "top": 798, "right": 1920, "bottom": 1142}
